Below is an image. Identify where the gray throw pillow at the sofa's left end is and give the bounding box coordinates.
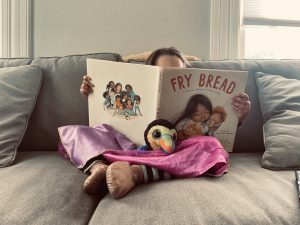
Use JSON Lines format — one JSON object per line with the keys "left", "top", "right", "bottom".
{"left": 0, "top": 66, "right": 42, "bottom": 167}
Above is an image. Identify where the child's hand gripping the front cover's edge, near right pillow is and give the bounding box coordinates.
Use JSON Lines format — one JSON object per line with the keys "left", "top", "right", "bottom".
{"left": 231, "top": 93, "right": 251, "bottom": 124}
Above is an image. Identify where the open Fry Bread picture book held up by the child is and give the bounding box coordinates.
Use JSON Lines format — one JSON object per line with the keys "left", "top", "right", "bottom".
{"left": 87, "top": 59, "right": 248, "bottom": 152}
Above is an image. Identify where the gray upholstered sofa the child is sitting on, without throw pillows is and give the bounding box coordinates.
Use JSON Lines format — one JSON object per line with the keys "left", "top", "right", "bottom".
{"left": 0, "top": 53, "right": 300, "bottom": 225}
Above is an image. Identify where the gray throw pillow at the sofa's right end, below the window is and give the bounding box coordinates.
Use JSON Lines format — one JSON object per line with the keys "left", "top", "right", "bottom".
{"left": 256, "top": 73, "right": 300, "bottom": 169}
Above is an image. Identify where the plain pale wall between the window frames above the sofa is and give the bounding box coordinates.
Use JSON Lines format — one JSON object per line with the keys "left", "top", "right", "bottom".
{"left": 33, "top": 0, "right": 210, "bottom": 58}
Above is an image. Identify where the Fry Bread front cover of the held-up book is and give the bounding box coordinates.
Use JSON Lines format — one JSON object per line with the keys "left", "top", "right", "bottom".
{"left": 158, "top": 68, "right": 248, "bottom": 152}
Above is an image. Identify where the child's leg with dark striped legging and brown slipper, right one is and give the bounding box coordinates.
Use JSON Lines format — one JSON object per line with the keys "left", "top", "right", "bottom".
{"left": 106, "top": 162, "right": 173, "bottom": 199}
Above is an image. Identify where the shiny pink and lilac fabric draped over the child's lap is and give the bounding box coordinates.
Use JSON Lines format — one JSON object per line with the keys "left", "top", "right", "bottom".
{"left": 59, "top": 125, "right": 228, "bottom": 177}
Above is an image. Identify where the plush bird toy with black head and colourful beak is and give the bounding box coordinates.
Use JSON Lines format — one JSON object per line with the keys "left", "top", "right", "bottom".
{"left": 139, "top": 119, "right": 177, "bottom": 154}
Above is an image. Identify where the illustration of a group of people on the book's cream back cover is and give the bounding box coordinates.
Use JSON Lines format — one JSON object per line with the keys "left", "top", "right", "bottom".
{"left": 103, "top": 81, "right": 143, "bottom": 120}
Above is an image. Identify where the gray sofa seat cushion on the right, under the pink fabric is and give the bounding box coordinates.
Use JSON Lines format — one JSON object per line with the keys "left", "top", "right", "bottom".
{"left": 89, "top": 153, "right": 300, "bottom": 225}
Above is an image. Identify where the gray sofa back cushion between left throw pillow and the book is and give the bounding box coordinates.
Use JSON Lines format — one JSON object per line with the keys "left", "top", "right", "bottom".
{"left": 20, "top": 53, "right": 121, "bottom": 150}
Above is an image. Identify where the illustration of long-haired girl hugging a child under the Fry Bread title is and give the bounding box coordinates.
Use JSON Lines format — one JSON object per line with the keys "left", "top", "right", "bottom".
{"left": 174, "top": 94, "right": 227, "bottom": 140}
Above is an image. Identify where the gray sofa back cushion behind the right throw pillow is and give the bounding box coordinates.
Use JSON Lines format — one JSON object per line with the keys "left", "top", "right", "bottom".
{"left": 191, "top": 60, "right": 300, "bottom": 152}
